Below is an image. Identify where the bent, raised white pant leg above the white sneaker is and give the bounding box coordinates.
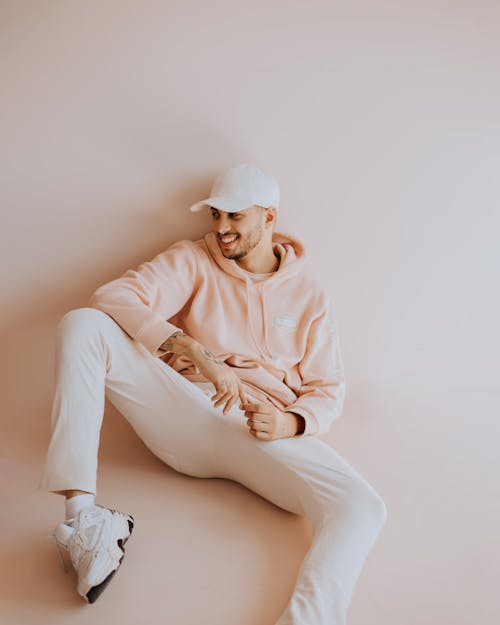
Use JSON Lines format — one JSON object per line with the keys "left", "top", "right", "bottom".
{"left": 39, "top": 308, "right": 232, "bottom": 493}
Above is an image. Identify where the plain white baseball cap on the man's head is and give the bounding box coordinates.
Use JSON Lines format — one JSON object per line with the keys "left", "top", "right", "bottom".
{"left": 189, "top": 163, "right": 280, "bottom": 213}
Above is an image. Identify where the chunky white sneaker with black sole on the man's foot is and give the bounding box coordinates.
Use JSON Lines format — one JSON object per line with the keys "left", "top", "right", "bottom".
{"left": 54, "top": 505, "right": 134, "bottom": 603}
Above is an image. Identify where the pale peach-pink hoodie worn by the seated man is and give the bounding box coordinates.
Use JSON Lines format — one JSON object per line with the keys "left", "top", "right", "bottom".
{"left": 89, "top": 232, "right": 345, "bottom": 436}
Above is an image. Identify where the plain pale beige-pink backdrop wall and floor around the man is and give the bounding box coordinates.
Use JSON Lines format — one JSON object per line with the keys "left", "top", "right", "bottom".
{"left": 0, "top": 0, "right": 500, "bottom": 625}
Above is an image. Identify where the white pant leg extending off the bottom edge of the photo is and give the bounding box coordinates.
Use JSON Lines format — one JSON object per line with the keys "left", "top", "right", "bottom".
{"left": 206, "top": 394, "right": 387, "bottom": 625}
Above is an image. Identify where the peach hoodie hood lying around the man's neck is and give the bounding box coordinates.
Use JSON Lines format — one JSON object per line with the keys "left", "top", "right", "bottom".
{"left": 204, "top": 232, "right": 306, "bottom": 283}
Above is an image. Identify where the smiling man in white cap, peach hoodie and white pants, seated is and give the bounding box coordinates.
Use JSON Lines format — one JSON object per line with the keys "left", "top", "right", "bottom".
{"left": 41, "top": 163, "right": 386, "bottom": 625}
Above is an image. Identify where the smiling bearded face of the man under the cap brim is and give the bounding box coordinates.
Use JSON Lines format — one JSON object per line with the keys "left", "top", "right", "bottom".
{"left": 210, "top": 205, "right": 266, "bottom": 260}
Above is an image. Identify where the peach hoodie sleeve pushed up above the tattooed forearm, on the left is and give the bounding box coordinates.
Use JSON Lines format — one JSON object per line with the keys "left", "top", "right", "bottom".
{"left": 88, "top": 240, "right": 198, "bottom": 356}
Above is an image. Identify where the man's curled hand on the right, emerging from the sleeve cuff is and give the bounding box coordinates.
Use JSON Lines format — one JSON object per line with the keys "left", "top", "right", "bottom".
{"left": 239, "top": 402, "right": 303, "bottom": 441}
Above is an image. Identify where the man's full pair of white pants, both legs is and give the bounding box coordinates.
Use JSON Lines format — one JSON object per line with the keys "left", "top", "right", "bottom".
{"left": 40, "top": 308, "right": 387, "bottom": 625}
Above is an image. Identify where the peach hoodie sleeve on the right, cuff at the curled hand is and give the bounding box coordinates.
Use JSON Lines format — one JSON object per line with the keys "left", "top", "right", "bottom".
{"left": 284, "top": 298, "right": 345, "bottom": 437}
